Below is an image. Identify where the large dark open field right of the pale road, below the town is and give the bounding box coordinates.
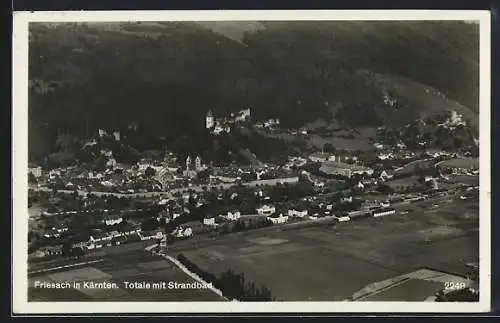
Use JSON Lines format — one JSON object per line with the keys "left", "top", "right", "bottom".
{"left": 178, "top": 201, "right": 479, "bottom": 301}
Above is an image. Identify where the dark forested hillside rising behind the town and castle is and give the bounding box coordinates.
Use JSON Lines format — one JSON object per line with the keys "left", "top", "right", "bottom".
{"left": 29, "top": 22, "right": 479, "bottom": 159}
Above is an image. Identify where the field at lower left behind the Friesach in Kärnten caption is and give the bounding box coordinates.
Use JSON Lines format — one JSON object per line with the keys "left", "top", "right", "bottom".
{"left": 28, "top": 242, "right": 222, "bottom": 301}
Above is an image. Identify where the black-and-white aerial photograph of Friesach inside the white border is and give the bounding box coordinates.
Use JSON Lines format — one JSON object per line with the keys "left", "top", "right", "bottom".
{"left": 26, "top": 21, "right": 480, "bottom": 302}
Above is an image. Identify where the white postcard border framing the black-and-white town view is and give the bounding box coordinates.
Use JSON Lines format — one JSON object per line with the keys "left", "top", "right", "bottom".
{"left": 12, "top": 10, "right": 491, "bottom": 314}
